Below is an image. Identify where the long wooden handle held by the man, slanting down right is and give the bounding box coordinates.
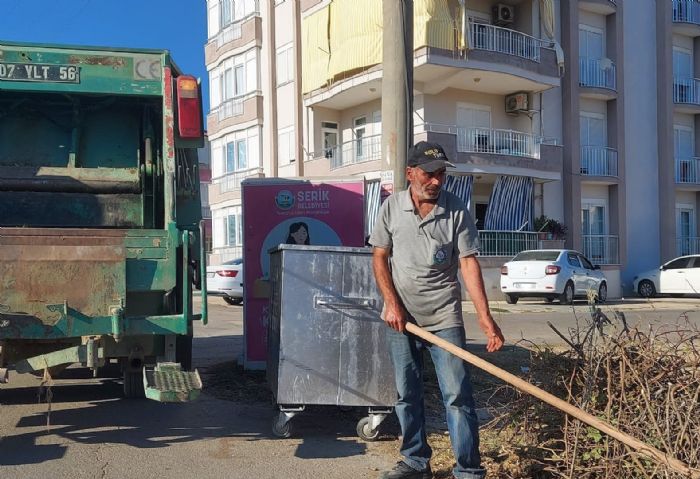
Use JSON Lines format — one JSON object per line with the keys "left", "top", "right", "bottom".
{"left": 406, "top": 323, "right": 700, "bottom": 479}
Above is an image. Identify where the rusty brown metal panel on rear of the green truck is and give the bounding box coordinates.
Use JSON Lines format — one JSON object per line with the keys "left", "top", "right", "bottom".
{"left": 0, "top": 246, "right": 126, "bottom": 332}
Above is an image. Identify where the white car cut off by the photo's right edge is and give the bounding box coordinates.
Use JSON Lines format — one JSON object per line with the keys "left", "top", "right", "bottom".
{"left": 633, "top": 254, "right": 700, "bottom": 298}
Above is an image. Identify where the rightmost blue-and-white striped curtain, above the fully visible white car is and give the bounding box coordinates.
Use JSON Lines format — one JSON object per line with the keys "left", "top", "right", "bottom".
{"left": 484, "top": 176, "right": 534, "bottom": 231}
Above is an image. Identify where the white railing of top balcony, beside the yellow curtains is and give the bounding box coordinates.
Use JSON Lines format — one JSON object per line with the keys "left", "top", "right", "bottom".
{"left": 469, "top": 22, "right": 550, "bottom": 62}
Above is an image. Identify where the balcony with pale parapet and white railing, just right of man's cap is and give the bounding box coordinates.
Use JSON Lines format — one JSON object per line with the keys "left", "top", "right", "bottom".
{"left": 414, "top": 123, "right": 563, "bottom": 181}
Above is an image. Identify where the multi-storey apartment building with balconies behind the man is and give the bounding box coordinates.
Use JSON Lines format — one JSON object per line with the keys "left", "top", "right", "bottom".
{"left": 206, "top": 0, "right": 700, "bottom": 297}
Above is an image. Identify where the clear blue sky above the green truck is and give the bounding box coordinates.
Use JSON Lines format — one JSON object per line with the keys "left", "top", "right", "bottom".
{"left": 0, "top": 0, "right": 209, "bottom": 112}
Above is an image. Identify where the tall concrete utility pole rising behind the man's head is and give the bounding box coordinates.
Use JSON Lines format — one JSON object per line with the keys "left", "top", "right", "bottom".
{"left": 381, "top": 0, "right": 413, "bottom": 194}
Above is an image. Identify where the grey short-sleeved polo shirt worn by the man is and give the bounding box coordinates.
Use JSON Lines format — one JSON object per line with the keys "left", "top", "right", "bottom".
{"left": 369, "top": 189, "right": 479, "bottom": 331}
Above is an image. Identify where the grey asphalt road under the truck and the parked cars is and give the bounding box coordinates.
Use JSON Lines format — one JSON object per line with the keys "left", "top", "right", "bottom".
{"left": 0, "top": 298, "right": 700, "bottom": 479}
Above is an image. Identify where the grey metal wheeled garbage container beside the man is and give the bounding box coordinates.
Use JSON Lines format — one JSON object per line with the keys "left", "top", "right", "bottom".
{"left": 267, "top": 245, "right": 397, "bottom": 441}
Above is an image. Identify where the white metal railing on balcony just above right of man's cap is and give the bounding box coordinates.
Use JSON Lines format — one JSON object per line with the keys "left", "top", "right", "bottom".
{"left": 455, "top": 127, "right": 543, "bottom": 159}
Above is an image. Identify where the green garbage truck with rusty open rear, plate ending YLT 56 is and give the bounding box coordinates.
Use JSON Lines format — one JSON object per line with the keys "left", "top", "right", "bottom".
{"left": 0, "top": 41, "right": 207, "bottom": 402}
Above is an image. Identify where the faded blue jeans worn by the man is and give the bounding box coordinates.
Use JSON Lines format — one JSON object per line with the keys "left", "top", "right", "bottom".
{"left": 387, "top": 328, "right": 486, "bottom": 479}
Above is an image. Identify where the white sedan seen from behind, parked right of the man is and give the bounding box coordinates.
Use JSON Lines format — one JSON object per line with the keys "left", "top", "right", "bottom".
{"left": 501, "top": 249, "right": 608, "bottom": 304}
